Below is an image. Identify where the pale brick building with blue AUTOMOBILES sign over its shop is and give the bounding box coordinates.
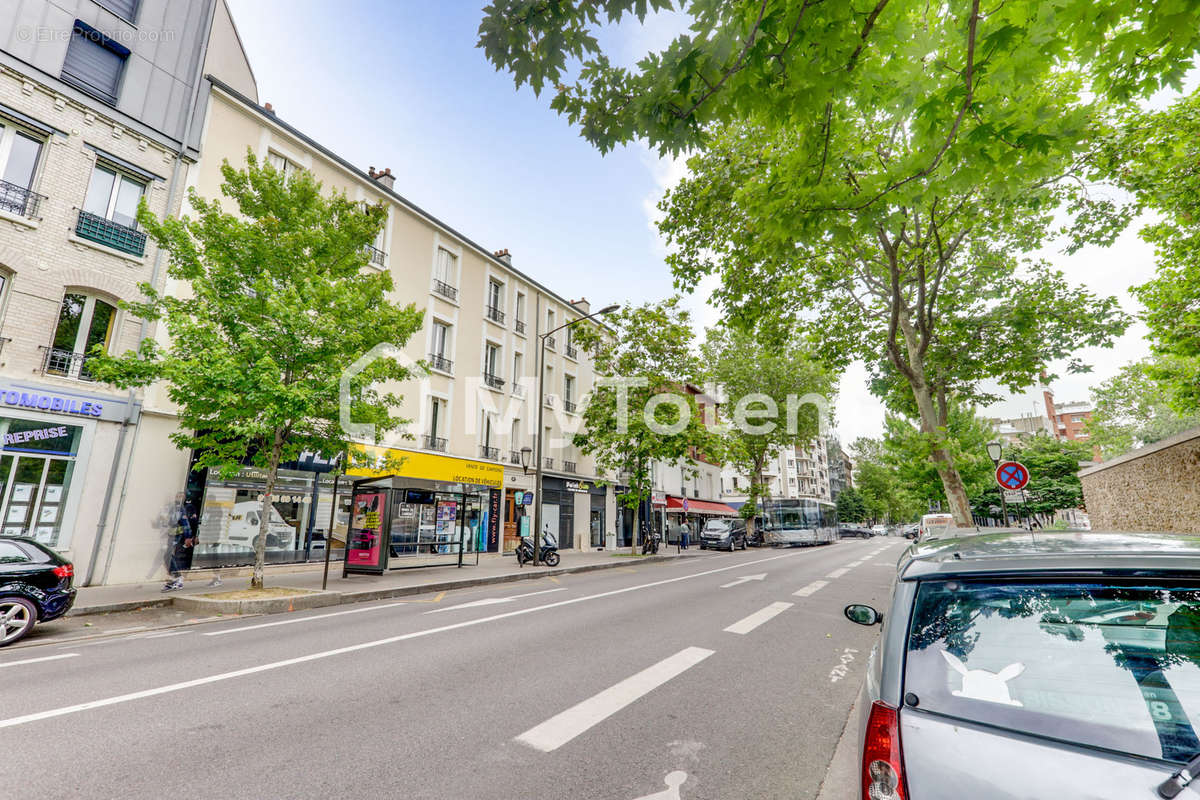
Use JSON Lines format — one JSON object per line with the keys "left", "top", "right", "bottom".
{"left": 0, "top": 0, "right": 252, "bottom": 583}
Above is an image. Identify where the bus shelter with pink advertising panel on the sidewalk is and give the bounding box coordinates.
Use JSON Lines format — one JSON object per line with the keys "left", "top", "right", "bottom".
{"left": 342, "top": 475, "right": 491, "bottom": 577}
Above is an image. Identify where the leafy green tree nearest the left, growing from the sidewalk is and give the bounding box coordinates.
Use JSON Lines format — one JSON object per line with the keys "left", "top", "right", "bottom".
{"left": 88, "top": 152, "right": 422, "bottom": 589}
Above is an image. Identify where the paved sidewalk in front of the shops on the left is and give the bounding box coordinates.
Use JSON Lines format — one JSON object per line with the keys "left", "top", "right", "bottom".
{"left": 68, "top": 547, "right": 709, "bottom": 616}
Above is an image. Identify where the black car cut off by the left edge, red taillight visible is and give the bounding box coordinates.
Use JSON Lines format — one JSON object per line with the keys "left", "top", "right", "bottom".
{"left": 0, "top": 536, "right": 76, "bottom": 648}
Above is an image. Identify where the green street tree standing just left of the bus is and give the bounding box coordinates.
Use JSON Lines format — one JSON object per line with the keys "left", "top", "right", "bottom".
{"left": 703, "top": 326, "right": 834, "bottom": 535}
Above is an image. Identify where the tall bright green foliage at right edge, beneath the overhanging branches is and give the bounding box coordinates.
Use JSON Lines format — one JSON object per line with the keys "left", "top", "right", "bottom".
{"left": 1100, "top": 92, "right": 1200, "bottom": 416}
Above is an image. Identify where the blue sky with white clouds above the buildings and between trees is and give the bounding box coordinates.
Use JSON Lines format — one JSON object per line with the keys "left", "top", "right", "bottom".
{"left": 228, "top": 0, "right": 1195, "bottom": 443}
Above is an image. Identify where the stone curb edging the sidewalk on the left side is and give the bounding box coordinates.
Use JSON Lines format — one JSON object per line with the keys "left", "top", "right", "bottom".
{"left": 66, "top": 555, "right": 695, "bottom": 616}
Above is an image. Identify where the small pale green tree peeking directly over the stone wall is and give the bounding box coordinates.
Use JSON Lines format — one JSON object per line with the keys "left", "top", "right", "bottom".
{"left": 1087, "top": 356, "right": 1200, "bottom": 458}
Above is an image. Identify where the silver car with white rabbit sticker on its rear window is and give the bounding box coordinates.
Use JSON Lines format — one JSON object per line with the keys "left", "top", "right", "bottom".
{"left": 845, "top": 531, "right": 1200, "bottom": 800}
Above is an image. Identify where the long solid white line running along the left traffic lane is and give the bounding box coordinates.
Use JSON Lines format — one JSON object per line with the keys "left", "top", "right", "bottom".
{"left": 0, "top": 551, "right": 803, "bottom": 728}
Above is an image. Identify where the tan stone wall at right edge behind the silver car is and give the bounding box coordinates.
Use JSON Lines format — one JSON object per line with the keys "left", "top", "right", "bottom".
{"left": 1079, "top": 428, "right": 1200, "bottom": 534}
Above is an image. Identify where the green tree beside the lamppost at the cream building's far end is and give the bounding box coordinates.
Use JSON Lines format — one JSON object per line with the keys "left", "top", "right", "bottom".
{"left": 574, "top": 297, "right": 718, "bottom": 554}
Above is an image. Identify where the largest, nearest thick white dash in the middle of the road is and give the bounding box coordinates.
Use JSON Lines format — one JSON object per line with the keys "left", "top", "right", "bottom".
{"left": 516, "top": 648, "right": 714, "bottom": 753}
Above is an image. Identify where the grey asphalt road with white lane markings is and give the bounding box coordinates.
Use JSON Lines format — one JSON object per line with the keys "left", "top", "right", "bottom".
{"left": 0, "top": 539, "right": 904, "bottom": 800}
